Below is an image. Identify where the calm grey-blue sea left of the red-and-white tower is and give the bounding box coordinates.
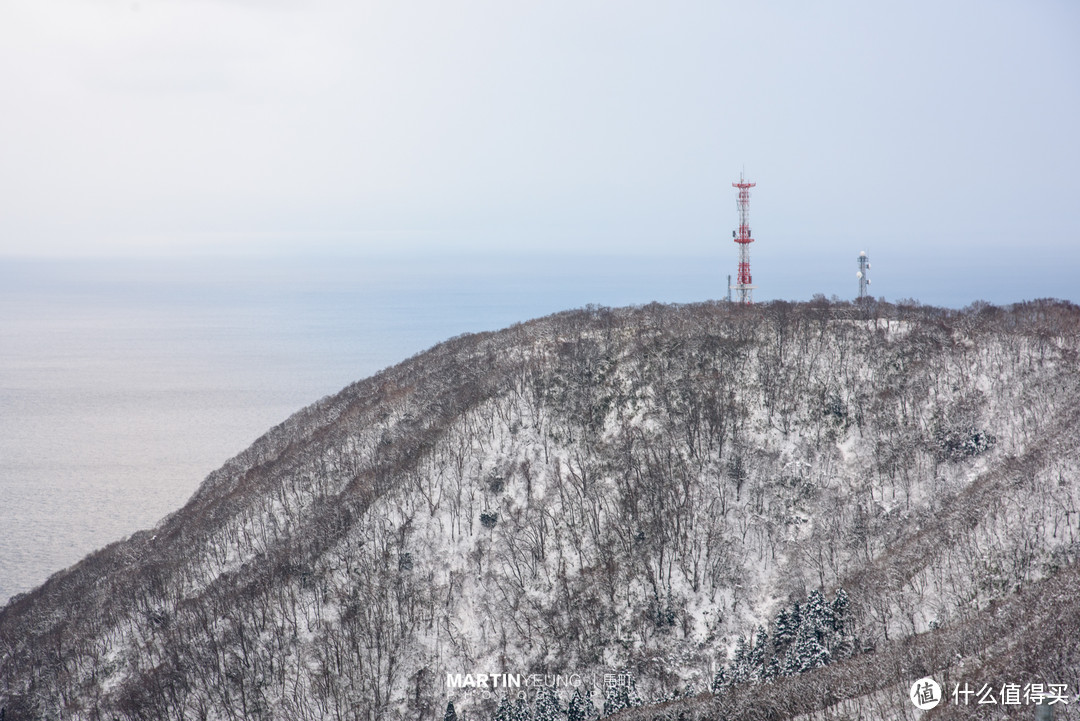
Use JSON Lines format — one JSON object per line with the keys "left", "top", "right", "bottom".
{"left": 0, "top": 254, "right": 727, "bottom": 604}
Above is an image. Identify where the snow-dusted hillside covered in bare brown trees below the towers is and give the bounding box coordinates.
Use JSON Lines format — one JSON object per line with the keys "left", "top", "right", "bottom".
{"left": 0, "top": 298, "right": 1080, "bottom": 721}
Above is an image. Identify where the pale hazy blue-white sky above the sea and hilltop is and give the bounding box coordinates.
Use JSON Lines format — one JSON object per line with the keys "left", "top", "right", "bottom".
{"left": 0, "top": 0, "right": 1080, "bottom": 300}
